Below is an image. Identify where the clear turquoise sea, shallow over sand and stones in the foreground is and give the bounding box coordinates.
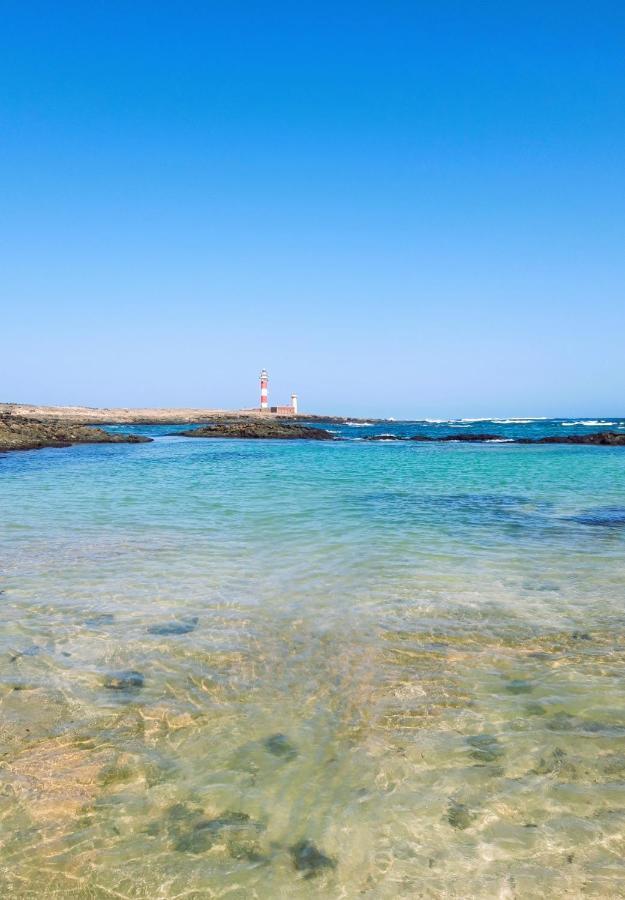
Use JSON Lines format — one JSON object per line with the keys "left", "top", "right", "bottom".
{"left": 0, "top": 419, "right": 625, "bottom": 898}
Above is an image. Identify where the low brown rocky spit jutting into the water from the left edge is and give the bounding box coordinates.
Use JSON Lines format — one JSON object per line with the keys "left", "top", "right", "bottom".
{"left": 0, "top": 415, "right": 152, "bottom": 453}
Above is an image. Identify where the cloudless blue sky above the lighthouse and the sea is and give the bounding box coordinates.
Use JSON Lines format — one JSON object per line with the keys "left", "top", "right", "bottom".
{"left": 0, "top": 0, "right": 625, "bottom": 418}
